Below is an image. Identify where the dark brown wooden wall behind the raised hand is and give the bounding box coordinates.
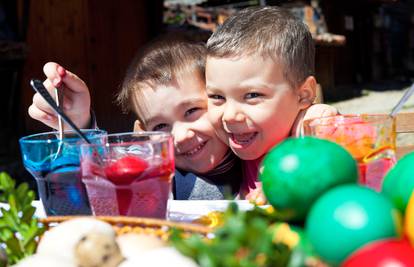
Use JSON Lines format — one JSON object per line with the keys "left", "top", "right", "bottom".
{"left": 21, "top": 0, "right": 162, "bottom": 133}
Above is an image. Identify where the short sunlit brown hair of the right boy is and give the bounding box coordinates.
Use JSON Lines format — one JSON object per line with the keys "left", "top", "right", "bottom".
{"left": 207, "top": 7, "right": 315, "bottom": 88}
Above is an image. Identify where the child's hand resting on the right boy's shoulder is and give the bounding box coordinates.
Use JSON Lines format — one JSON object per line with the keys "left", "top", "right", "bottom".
{"left": 292, "top": 104, "right": 338, "bottom": 137}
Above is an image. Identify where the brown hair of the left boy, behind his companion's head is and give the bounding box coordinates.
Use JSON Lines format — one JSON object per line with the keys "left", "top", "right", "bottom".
{"left": 117, "top": 38, "right": 206, "bottom": 124}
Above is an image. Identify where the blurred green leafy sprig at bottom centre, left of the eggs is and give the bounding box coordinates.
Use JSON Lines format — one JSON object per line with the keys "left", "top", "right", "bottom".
{"left": 170, "top": 203, "right": 291, "bottom": 267}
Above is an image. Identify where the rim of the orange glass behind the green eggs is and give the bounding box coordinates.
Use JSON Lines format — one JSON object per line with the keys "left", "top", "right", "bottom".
{"left": 303, "top": 113, "right": 395, "bottom": 127}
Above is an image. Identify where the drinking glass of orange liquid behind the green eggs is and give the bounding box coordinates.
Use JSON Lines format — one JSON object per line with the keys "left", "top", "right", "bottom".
{"left": 304, "top": 114, "right": 396, "bottom": 191}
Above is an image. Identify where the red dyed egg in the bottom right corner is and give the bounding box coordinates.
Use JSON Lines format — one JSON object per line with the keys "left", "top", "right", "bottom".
{"left": 342, "top": 239, "right": 414, "bottom": 267}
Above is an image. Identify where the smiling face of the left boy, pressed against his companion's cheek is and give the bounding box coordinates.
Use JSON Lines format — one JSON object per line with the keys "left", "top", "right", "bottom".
{"left": 137, "top": 72, "right": 228, "bottom": 173}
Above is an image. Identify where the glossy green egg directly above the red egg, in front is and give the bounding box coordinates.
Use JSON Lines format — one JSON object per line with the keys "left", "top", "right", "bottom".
{"left": 306, "top": 185, "right": 400, "bottom": 264}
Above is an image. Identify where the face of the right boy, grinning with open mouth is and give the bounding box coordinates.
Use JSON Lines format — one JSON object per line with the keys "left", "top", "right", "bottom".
{"left": 206, "top": 55, "right": 304, "bottom": 160}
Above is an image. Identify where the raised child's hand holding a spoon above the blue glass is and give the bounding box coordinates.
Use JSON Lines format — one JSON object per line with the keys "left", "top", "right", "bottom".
{"left": 28, "top": 62, "right": 91, "bottom": 129}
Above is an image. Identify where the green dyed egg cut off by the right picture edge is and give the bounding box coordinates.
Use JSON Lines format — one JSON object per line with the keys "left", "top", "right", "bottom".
{"left": 382, "top": 153, "right": 414, "bottom": 212}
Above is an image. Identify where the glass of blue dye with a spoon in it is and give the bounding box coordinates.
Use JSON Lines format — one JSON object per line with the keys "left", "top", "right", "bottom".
{"left": 19, "top": 130, "right": 106, "bottom": 216}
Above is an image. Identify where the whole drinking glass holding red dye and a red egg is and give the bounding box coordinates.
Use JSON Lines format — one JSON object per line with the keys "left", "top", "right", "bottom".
{"left": 81, "top": 132, "right": 174, "bottom": 219}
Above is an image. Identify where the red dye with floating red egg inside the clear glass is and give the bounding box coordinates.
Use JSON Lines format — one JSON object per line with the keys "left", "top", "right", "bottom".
{"left": 82, "top": 156, "right": 174, "bottom": 218}
